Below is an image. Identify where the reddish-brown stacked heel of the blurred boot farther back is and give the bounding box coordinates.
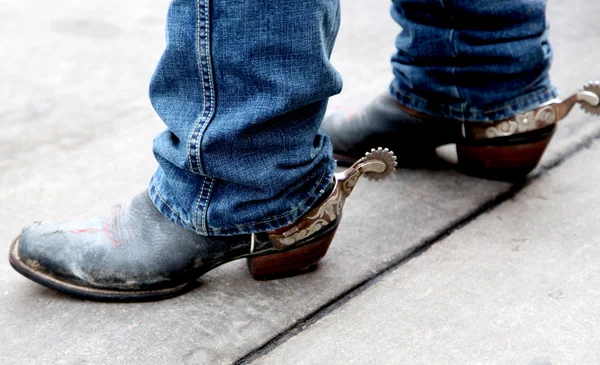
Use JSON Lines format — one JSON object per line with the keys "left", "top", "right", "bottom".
{"left": 456, "top": 125, "right": 555, "bottom": 181}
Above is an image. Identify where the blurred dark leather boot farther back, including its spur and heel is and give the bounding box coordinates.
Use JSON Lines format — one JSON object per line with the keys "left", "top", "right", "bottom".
{"left": 321, "top": 81, "right": 600, "bottom": 181}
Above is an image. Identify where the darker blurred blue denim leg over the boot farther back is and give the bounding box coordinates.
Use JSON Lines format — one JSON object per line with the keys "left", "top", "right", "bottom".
{"left": 390, "top": 0, "right": 557, "bottom": 121}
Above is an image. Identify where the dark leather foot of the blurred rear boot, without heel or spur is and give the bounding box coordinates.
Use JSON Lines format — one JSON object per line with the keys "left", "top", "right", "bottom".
{"left": 321, "top": 92, "right": 461, "bottom": 166}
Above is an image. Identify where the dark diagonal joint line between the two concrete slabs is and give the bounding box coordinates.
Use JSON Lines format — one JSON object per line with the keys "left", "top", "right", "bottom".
{"left": 235, "top": 125, "right": 600, "bottom": 365}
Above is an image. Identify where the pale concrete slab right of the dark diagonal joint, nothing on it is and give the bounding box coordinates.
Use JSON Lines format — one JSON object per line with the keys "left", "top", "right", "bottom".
{"left": 253, "top": 136, "right": 600, "bottom": 365}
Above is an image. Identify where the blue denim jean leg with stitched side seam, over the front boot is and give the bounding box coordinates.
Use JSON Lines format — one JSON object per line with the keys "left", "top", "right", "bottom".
{"left": 148, "top": 0, "right": 341, "bottom": 235}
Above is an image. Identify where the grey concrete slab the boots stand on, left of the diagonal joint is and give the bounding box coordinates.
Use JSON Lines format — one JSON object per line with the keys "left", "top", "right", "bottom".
{"left": 0, "top": 0, "right": 600, "bottom": 365}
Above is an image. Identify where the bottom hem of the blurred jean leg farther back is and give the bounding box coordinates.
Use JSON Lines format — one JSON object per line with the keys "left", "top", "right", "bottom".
{"left": 390, "top": 81, "right": 558, "bottom": 123}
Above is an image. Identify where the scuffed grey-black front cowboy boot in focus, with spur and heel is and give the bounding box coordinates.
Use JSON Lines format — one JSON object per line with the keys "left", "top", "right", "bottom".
{"left": 10, "top": 150, "right": 395, "bottom": 301}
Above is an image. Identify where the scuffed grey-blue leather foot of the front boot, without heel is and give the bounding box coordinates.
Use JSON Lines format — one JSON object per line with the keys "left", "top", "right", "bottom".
{"left": 10, "top": 188, "right": 338, "bottom": 301}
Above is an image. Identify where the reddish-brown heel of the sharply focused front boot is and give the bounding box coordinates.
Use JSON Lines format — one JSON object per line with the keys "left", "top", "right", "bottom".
{"left": 247, "top": 230, "right": 335, "bottom": 280}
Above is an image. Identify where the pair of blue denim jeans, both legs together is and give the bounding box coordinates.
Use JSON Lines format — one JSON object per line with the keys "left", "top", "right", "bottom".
{"left": 148, "top": 0, "right": 554, "bottom": 235}
